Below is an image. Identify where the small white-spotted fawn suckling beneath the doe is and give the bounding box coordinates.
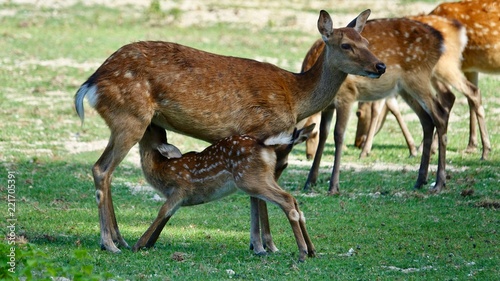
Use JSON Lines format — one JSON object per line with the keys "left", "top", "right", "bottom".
{"left": 133, "top": 124, "right": 315, "bottom": 261}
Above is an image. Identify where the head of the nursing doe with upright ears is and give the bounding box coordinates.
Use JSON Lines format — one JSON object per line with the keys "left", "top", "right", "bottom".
{"left": 318, "top": 10, "right": 386, "bottom": 78}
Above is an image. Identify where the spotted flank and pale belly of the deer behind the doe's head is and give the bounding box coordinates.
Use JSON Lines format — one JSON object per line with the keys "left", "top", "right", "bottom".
{"left": 336, "top": 18, "right": 444, "bottom": 101}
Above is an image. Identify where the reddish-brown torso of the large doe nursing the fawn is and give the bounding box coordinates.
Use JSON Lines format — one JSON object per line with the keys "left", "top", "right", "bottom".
{"left": 89, "top": 42, "right": 296, "bottom": 142}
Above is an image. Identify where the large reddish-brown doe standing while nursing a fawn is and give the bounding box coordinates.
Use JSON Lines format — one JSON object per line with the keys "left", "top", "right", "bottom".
{"left": 75, "top": 10, "right": 385, "bottom": 252}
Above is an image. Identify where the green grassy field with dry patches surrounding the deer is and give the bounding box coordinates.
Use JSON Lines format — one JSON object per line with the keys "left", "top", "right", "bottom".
{"left": 0, "top": 1, "right": 500, "bottom": 280}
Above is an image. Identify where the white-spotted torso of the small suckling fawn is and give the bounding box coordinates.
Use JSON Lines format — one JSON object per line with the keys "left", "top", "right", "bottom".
{"left": 140, "top": 129, "right": 280, "bottom": 206}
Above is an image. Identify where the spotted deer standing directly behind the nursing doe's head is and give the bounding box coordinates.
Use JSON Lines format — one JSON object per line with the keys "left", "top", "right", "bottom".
{"left": 303, "top": 18, "right": 455, "bottom": 194}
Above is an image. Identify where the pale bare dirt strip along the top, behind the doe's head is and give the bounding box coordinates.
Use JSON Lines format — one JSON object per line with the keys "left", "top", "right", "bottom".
{"left": 0, "top": 0, "right": 435, "bottom": 32}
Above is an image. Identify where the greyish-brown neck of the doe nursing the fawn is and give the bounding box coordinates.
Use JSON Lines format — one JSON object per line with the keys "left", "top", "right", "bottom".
{"left": 295, "top": 48, "right": 347, "bottom": 121}
